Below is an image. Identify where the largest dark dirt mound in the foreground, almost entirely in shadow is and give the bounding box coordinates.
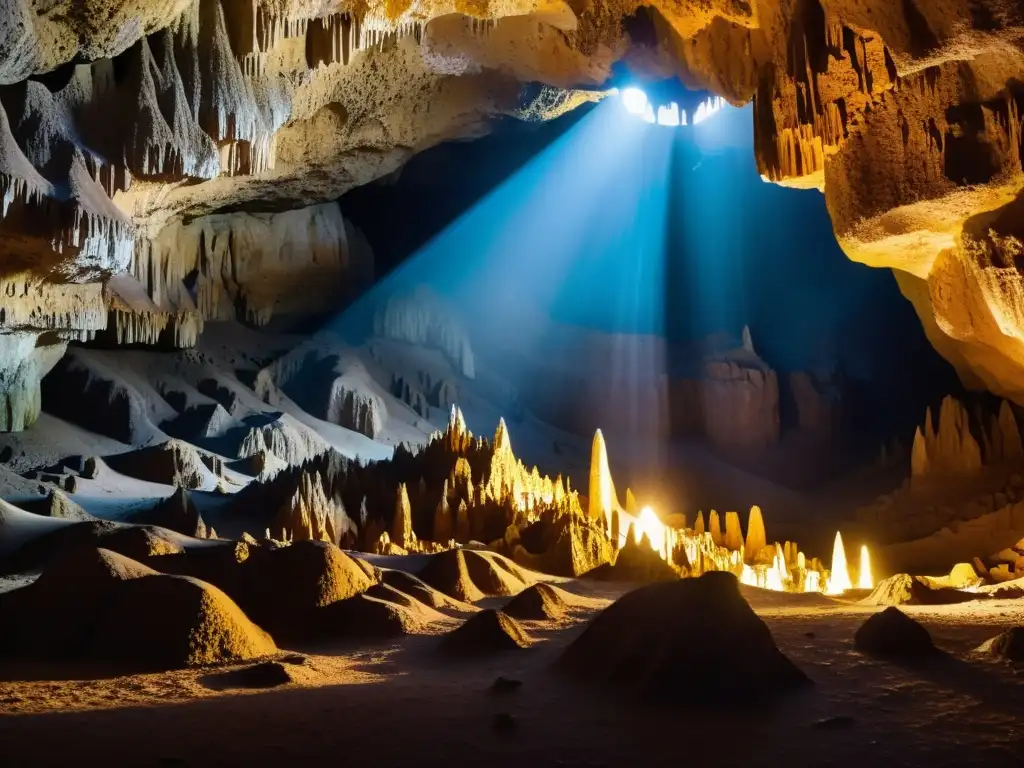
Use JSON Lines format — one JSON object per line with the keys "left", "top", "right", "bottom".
{"left": 560, "top": 571, "right": 810, "bottom": 708}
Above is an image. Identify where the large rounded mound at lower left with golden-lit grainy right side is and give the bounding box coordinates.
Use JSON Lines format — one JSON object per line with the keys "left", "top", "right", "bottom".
{"left": 89, "top": 574, "right": 278, "bottom": 669}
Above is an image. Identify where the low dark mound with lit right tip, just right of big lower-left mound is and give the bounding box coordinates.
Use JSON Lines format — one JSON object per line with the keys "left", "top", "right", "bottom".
{"left": 317, "top": 594, "right": 441, "bottom": 640}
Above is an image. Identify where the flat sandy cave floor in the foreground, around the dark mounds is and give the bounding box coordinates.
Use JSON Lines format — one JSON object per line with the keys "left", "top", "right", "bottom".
{"left": 0, "top": 582, "right": 1024, "bottom": 767}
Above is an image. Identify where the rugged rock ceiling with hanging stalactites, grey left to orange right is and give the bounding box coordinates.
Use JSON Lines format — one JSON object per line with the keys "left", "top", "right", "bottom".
{"left": 0, "top": 0, "right": 1024, "bottom": 429}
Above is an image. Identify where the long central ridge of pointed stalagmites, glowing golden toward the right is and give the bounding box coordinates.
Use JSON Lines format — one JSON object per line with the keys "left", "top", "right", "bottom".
{"left": 220, "top": 408, "right": 828, "bottom": 592}
